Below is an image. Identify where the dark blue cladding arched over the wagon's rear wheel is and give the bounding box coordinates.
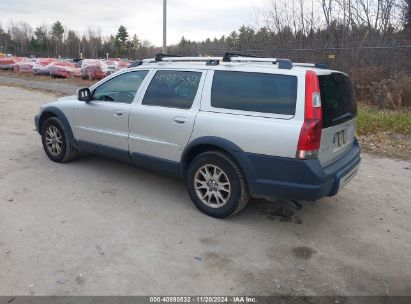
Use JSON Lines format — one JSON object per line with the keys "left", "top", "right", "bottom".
{"left": 181, "top": 136, "right": 255, "bottom": 185}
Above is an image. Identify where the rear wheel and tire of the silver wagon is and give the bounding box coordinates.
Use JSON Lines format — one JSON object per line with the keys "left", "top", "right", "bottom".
{"left": 186, "top": 151, "right": 249, "bottom": 218}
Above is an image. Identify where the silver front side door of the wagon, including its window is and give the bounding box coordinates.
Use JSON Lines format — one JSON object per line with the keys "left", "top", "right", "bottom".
{"left": 74, "top": 70, "right": 149, "bottom": 157}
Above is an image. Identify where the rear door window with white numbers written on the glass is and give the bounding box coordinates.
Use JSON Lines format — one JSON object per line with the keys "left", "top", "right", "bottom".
{"left": 143, "top": 71, "right": 201, "bottom": 109}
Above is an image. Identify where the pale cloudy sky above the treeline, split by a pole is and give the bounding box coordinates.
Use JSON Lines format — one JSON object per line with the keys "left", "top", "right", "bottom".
{"left": 0, "top": 0, "right": 267, "bottom": 46}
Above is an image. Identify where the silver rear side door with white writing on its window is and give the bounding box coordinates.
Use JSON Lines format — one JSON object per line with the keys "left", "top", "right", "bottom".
{"left": 129, "top": 69, "right": 206, "bottom": 162}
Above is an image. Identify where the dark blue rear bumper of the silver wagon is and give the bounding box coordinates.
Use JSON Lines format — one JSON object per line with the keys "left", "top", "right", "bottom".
{"left": 246, "top": 140, "right": 361, "bottom": 200}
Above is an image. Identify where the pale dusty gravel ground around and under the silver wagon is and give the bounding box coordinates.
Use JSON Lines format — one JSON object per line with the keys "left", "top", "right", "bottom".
{"left": 0, "top": 87, "right": 411, "bottom": 295}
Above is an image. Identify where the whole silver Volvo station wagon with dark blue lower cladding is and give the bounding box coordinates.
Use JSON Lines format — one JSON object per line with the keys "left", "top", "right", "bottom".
{"left": 35, "top": 53, "right": 360, "bottom": 218}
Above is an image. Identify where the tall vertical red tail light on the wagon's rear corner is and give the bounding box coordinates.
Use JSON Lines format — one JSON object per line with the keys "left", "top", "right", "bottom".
{"left": 297, "top": 70, "right": 322, "bottom": 159}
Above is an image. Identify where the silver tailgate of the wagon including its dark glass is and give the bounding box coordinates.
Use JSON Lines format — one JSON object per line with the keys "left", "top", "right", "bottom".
{"left": 318, "top": 73, "right": 357, "bottom": 167}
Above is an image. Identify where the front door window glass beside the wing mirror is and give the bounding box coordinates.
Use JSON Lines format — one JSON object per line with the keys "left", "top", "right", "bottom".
{"left": 93, "top": 71, "right": 148, "bottom": 103}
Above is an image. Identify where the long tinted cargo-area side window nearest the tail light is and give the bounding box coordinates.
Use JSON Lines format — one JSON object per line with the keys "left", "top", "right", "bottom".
{"left": 211, "top": 71, "right": 297, "bottom": 115}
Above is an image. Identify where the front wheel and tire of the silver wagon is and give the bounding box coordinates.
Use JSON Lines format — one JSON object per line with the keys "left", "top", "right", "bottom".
{"left": 41, "top": 117, "right": 78, "bottom": 163}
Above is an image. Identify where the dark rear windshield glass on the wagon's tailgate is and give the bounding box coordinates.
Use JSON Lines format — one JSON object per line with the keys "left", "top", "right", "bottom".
{"left": 318, "top": 73, "right": 357, "bottom": 129}
